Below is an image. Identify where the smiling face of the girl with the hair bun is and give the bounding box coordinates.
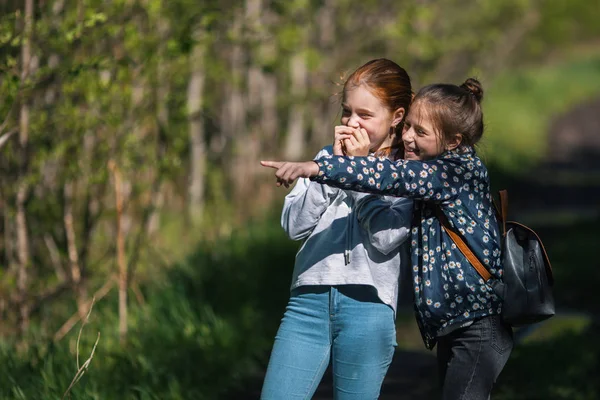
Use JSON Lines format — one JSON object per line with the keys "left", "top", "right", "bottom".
{"left": 402, "top": 102, "right": 444, "bottom": 161}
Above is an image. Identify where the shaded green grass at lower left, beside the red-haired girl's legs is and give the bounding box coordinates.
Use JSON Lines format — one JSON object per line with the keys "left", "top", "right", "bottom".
{"left": 0, "top": 212, "right": 297, "bottom": 400}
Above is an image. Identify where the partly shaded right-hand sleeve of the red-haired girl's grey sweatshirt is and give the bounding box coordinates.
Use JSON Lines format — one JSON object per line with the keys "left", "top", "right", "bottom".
{"left": 347, "top": 191, "right": 413, "bottom": 255}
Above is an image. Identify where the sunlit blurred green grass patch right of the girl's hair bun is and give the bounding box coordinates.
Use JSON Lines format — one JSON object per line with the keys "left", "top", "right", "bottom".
{"left": 480, "top": 54, "right": 600, "bottom": 172}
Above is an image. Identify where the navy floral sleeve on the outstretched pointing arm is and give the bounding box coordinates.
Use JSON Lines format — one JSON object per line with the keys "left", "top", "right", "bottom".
{"left": 312, "top": 153, "right": 482, "bottom": 202}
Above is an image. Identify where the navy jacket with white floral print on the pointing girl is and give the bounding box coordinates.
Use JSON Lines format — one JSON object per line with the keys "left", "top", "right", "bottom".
{"left": 313, "top": 148, "right": 502, "bottom": 349}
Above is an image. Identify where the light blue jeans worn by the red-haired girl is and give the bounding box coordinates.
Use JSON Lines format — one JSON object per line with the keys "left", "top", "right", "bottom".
{"left": 261, "top": 285, "right": 396, "bottom": 400}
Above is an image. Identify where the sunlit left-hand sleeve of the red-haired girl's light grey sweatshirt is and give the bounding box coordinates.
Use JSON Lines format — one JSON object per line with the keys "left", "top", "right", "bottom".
{"left": 281, "top": 147, "right": 340, "bottom": 240}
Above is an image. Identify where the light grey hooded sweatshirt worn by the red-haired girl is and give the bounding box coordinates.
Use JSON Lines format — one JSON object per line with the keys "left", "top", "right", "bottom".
{"left": 281, "top": 146, "right": 413, "bottom": 313}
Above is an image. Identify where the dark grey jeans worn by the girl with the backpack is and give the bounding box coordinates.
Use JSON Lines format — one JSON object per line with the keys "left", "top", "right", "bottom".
{"left": 437, "top": 315, "right": 513, "bottom": 400}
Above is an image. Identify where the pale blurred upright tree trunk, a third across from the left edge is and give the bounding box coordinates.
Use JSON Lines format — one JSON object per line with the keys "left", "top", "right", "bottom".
{"left": 187, "top": 26, "right": 206, "bottom": 224}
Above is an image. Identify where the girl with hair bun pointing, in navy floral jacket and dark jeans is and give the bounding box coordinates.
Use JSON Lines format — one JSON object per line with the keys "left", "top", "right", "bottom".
{"left": 262, "top": 78, "right": 513, "bottom": 400}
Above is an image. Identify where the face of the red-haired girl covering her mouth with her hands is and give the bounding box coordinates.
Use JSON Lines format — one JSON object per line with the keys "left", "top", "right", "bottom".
{"left": 341, "top": 85, "right": 404, "bottom": 152}
